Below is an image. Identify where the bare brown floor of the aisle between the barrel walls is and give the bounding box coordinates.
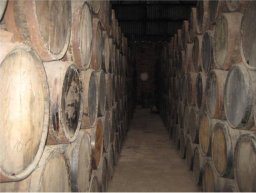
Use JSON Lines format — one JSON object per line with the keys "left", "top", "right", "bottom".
{"left": 109, "top": 109, "right": 199, "bottom": 192}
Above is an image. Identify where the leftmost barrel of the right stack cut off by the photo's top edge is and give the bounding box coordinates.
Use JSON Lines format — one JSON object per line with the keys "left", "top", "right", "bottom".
{"left": 196, "top": 0, "right": 209, "bottom": 33}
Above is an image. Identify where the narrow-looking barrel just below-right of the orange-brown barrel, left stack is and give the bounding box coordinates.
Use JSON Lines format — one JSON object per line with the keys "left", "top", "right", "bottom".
{"left": 96, "top": 156, "right": 109, "bottom": 192}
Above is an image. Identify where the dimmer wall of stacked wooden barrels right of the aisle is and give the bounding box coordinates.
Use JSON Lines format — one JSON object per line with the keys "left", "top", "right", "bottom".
{"left": 161, "top": 1, "right": 256, "bottom": 191}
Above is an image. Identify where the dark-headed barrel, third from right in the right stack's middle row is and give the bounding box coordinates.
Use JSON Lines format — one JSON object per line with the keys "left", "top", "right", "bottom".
{"left": 196, "top": 72, "right": 207, "bottom": 110}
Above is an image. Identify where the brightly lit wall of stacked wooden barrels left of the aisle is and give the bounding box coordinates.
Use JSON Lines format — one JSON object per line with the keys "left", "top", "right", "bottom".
{"left": 0, "top": 0, "right": 134, "bottom": 192}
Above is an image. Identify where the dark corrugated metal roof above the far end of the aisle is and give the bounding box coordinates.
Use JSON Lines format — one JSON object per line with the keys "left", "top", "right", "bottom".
{"left": 112, "top": 0, "right": 196, "bottom": 40}
